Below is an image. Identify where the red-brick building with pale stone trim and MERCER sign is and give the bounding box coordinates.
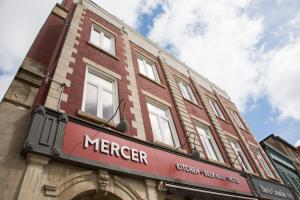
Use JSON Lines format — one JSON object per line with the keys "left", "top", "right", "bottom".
{"left": 0, "top": 0, "right": 297, "bottom": 200}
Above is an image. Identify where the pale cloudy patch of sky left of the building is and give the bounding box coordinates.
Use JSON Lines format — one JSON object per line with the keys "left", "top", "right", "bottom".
{"left": 0, "top": 0, "right": 58, "bottom": 99}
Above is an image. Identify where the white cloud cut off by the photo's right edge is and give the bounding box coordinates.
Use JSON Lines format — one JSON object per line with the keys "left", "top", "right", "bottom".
{"left": 264, "top": 37, "right": 300, "bottom": 120}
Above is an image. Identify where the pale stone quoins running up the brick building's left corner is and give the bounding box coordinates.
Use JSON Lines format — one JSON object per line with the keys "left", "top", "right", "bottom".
{"left": 45, "top": 4, "right": 86, "bottom": 112}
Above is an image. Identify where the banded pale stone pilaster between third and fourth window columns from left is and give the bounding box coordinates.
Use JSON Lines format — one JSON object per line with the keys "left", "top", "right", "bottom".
{"left": 192, "top": 82, "right": 242, "bottom": 170}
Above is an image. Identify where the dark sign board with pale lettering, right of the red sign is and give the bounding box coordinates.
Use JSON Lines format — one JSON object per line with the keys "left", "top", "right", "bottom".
{"left": 249, "top": 177, "right": 297, "bottom": 200}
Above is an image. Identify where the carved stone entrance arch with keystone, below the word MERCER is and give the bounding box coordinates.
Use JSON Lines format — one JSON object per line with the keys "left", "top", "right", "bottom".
{"left": 44, "top": 170, "right": 143, "bottom": 200}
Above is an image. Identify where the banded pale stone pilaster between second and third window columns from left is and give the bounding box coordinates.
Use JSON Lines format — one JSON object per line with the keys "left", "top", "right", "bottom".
{"left": 159, "top": 57, "right": 205, "bottom": 158}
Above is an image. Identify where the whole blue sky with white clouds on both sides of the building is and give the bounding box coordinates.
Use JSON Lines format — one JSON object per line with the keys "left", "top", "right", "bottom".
{"left": 0, "top": 0, "right": 300, "bottom": 146}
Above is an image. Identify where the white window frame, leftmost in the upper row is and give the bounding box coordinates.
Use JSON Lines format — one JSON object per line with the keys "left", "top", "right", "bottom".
{"left": 90, "top": 24, "right": 116, "bottom": 56}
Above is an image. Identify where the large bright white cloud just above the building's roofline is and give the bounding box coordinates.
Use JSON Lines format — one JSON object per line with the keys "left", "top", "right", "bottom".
{"left": 149, "top": 0, "right": 263, "bottom": 108}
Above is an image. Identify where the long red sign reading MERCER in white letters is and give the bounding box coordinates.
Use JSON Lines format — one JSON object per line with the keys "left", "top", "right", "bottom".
{"left": 62, "top": 122, "right": 251, "bottom": 194}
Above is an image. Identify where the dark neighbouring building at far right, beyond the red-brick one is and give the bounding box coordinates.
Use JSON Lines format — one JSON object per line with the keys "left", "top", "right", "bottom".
{"left": 260, "top": 134, "right": 300, "bottom": 199}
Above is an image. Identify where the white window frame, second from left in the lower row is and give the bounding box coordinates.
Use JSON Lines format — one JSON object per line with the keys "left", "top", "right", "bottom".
{"left": 147, "top": 98, "right": 180, "bottom": 147}
